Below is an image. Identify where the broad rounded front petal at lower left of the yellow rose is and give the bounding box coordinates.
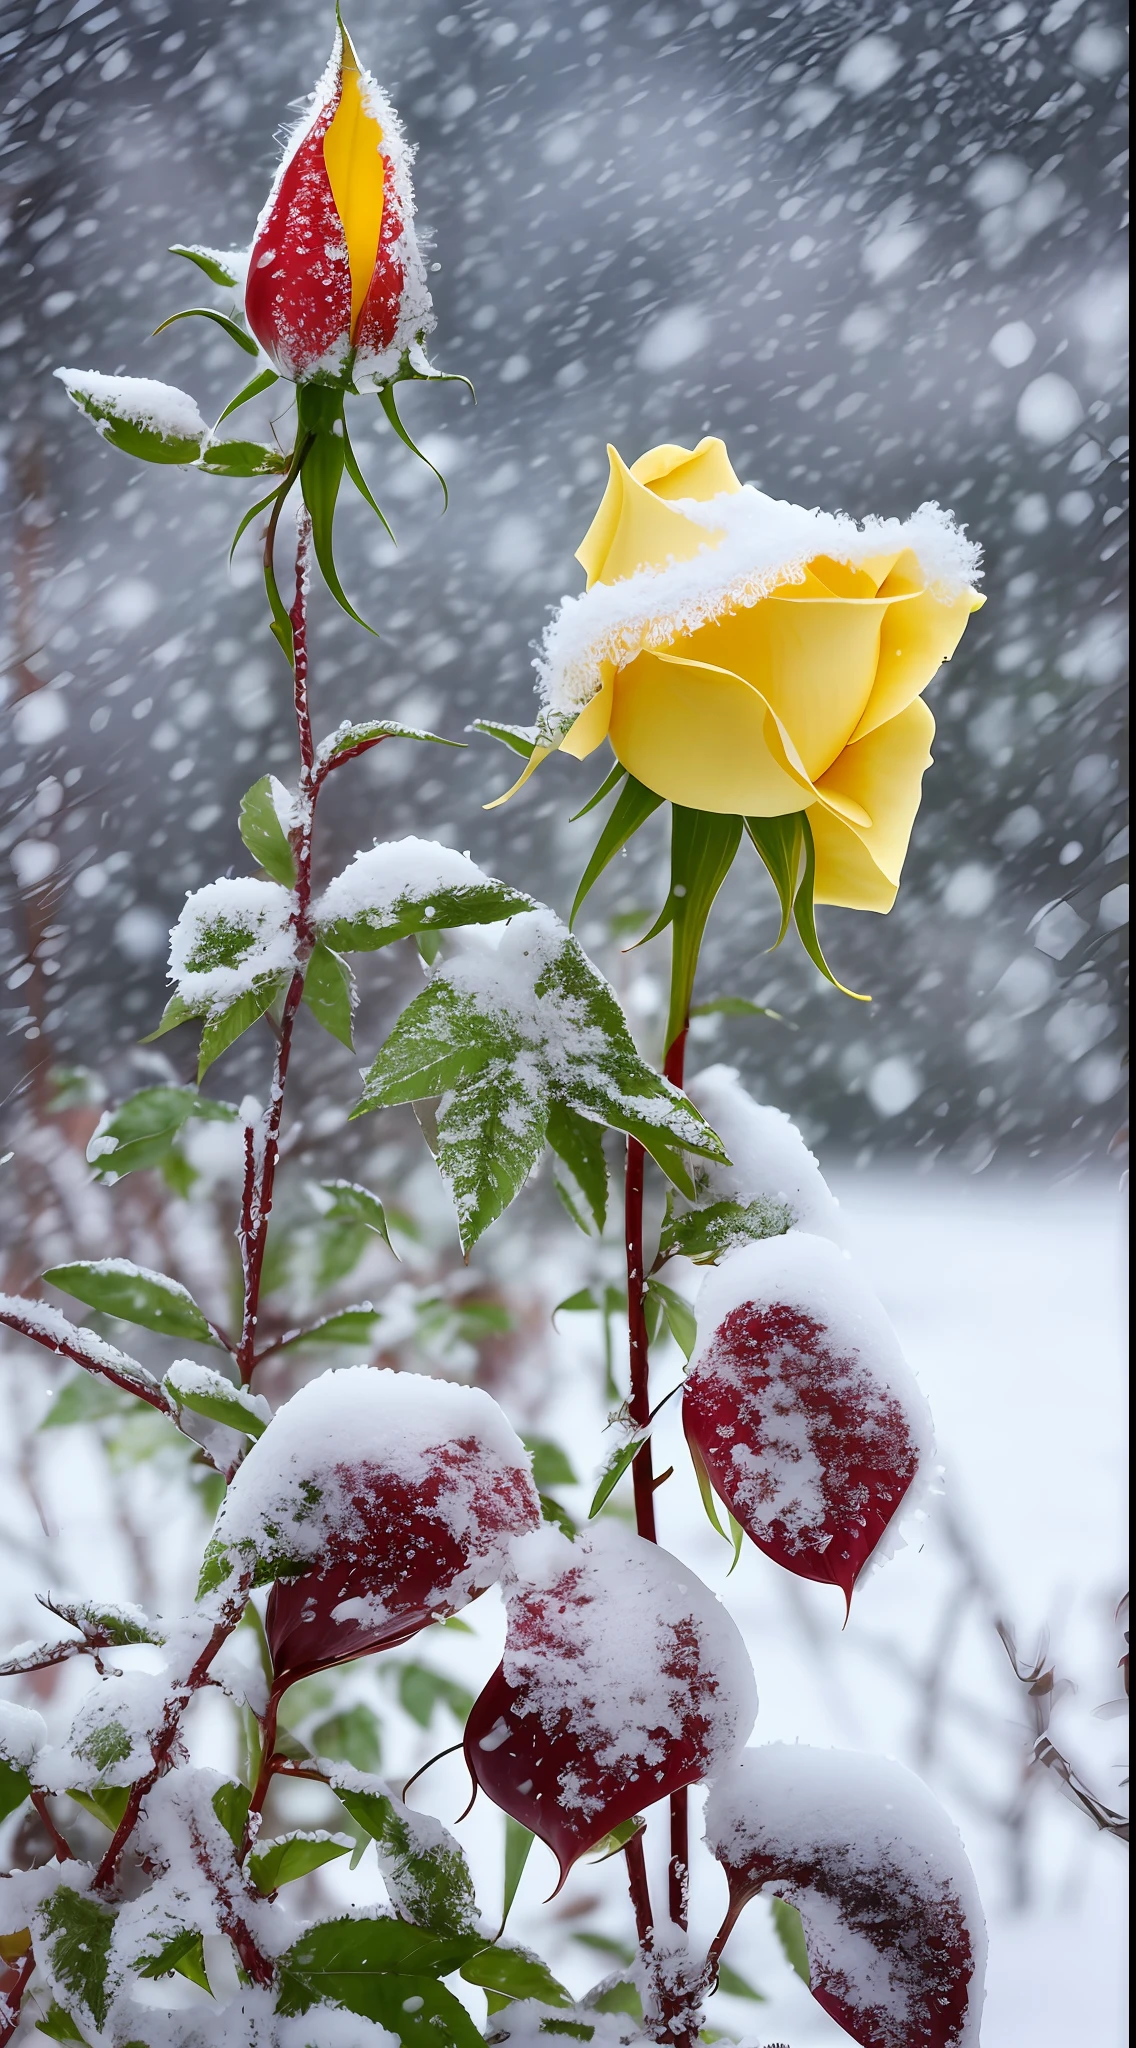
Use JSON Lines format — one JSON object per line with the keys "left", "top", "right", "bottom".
{"left": 608, "top": 653, "right": 813, "bottom": 817}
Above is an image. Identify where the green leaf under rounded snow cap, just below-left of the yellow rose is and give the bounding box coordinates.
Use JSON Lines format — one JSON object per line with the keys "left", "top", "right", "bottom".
{"left": 313, "top": 838, "right": 532, "bottom": 952}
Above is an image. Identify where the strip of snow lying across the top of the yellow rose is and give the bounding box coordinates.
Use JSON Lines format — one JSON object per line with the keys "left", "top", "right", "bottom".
{"left": 536, "top": 483, "right": 980, "bottom": 731}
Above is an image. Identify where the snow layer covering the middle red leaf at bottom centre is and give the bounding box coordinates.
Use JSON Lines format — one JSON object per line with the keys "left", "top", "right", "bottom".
{"left": 501, "top": 1522, "right": 757, "bottom": 1812}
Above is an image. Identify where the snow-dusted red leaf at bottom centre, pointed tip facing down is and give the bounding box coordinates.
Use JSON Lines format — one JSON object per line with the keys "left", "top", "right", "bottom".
{"left": 465, "top": 1522, "right": 757, "bottom": 1882}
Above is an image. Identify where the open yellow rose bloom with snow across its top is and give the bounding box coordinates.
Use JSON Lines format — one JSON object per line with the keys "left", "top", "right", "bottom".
{"left": 501, "top": 440, "right": 982, "bottom": 911}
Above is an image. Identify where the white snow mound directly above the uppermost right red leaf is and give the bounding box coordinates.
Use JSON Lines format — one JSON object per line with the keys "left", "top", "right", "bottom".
{"left": 686, "top": 1067, "right": 845, "bottom": 1245}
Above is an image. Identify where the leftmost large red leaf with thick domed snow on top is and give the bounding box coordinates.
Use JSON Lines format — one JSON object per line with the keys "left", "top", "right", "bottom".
{"left": 201, "top": 1366, "right": 540, "bottom": 1690}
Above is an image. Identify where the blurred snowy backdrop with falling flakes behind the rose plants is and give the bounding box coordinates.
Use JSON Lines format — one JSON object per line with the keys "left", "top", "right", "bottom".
{"left": 0, "top": 0, "right": 1128, "bottom": 2048}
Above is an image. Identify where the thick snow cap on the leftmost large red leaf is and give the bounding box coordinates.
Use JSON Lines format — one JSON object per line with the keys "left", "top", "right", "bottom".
{"left": 215, "top": 1366, "right": 540, "bottom": 1589}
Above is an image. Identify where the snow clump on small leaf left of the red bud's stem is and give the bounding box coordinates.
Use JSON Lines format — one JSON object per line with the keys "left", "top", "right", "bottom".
{"left": 170, "top": 874, "right": 295, "bottom": 1016}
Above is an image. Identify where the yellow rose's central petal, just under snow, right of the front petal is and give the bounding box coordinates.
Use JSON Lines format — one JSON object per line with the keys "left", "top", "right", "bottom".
{"left": 671, "top": 598, "right": 888, "bottom": 786}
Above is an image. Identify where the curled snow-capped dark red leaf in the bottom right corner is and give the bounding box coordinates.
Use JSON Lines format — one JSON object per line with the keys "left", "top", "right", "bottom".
{"left": 706, "top": 1743, "right": 987, "bottom": 2048}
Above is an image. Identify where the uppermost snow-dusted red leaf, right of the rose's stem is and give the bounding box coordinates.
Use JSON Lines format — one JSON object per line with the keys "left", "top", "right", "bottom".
{"left": 682, "top": 1231, "right": 933, "bottom": 1602}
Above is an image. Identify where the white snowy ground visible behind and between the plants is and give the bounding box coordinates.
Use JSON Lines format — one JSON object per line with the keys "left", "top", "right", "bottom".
{"left": 4, "top": 1171, "right": 1126, "bottom": 2048}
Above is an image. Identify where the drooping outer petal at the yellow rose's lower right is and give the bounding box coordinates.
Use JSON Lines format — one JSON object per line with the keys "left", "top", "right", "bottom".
{"left": 809, "top": 696, "right": 935, "bottom": 911}
